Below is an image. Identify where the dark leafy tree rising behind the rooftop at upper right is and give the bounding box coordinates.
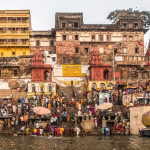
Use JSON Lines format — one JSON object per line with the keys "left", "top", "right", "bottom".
{"left": 107, "top": 8, "right": 150, "bottom": 28}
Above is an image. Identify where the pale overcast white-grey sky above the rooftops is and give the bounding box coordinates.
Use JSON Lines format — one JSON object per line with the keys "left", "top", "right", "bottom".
{"left": 0, "top": 0, "right": 150, "bottom": 45}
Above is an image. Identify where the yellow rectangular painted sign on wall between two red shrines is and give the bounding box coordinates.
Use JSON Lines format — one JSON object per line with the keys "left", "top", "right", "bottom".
{"left": 62, "top": 65, "right": 81, "bottom": 77}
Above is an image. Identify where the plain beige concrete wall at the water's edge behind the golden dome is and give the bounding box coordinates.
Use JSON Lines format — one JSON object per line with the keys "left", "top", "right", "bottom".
{"left": 130, "top": 106, "right": 150, "bottom": 134}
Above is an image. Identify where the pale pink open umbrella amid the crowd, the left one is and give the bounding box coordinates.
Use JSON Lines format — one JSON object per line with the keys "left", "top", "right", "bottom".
{"left": 33, "top": 107, "right": 51, "bottom": 115}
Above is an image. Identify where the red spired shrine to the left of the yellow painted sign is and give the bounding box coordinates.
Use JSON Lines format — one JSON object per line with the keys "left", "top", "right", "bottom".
{"left": 31, "top": 47, "right": 52, "bottom": 82}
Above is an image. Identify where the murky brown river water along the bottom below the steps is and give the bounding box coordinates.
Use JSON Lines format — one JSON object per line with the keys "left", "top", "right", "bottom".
{"left": 0, "top": 136, "right": 150, "bottom": 150}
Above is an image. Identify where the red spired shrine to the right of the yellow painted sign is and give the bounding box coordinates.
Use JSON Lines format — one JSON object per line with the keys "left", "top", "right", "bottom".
{"left": 90, "top": 47, "right": 111, "bottom": 81}
